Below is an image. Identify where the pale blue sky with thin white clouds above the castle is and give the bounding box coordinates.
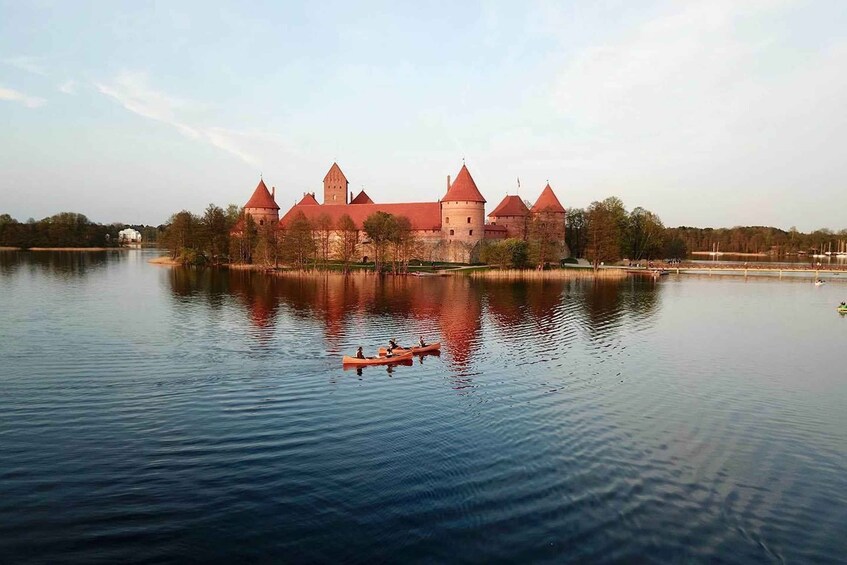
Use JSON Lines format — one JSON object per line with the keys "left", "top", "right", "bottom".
{"left": 0, "top": 0, "right": 847, "bottom": 231}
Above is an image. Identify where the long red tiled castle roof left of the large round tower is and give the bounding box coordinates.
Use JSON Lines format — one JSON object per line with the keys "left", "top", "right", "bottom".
{"left": 279, "top": 202, "right": 441, "bottom": 230}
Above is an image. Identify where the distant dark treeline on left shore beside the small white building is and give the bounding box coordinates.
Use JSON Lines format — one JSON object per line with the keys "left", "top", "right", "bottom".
{"left": 0, "top": 212, "right": 158, "bottom": 249}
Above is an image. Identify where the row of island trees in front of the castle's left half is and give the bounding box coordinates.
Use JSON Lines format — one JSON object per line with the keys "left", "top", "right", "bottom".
{"left": 160, "top": 204, "right": 421, "bottom": 272}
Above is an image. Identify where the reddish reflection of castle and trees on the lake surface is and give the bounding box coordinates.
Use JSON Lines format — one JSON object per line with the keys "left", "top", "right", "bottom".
{"left": 162, "top": 268, "right": 658, "bottom": 374}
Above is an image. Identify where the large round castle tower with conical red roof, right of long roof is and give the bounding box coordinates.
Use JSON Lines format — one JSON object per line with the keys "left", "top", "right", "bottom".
{"left": 441, "top": 165, "right": 485, "bottom": 263}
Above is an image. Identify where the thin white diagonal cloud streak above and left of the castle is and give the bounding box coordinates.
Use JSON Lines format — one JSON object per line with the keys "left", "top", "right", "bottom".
{"left": 95, "top": 72, "right": 265, "bottom": 167}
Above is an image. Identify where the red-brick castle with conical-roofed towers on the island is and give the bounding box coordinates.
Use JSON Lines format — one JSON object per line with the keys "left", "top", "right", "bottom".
{"left": 234, "top": 163, "right": 569, "bottom": 263}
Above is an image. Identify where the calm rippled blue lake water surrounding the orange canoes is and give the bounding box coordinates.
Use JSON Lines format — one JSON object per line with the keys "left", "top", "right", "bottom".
{"left": 0, "top": 251, "right": 847, "bottom": 563}
